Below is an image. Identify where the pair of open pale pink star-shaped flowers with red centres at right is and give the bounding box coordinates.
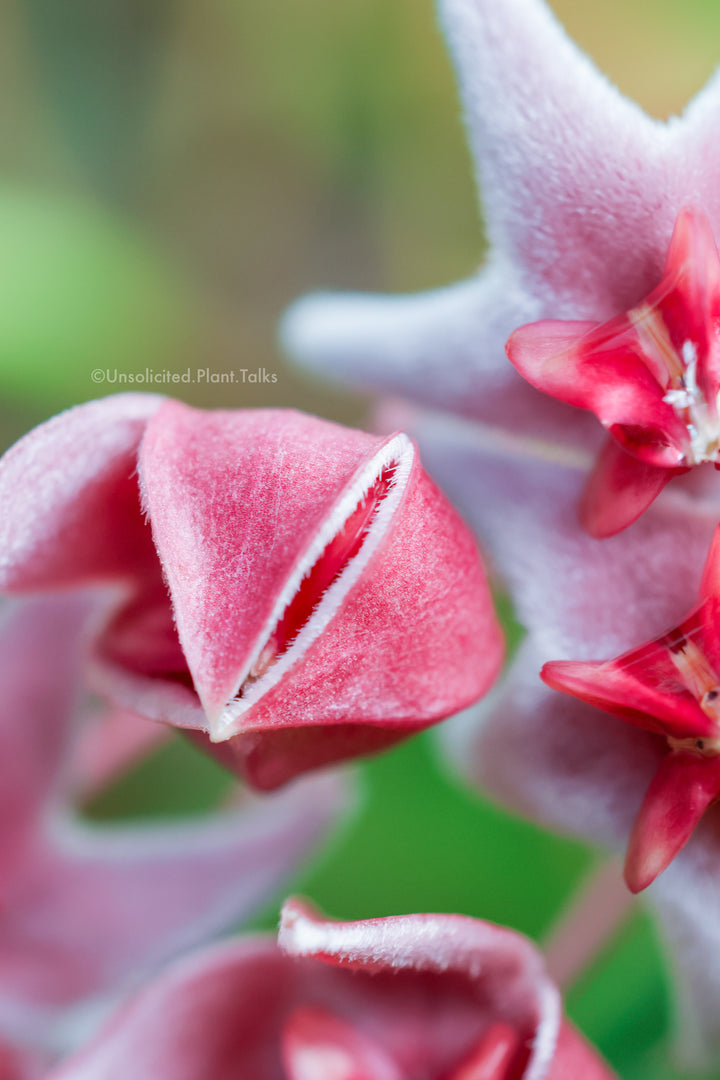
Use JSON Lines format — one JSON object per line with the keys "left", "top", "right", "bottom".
{"left": 283, "top": 0, "right": 720, "bottom": 1064}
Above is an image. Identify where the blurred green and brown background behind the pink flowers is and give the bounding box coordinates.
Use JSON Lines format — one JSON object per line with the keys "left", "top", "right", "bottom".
{"left": 0, "top": 0, "right": 720, "bottom": 1080}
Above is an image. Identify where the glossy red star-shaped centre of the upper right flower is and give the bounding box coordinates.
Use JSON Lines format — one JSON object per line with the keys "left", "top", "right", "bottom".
{"left": 507, "top": 208, "right": 720, "bottom": 537}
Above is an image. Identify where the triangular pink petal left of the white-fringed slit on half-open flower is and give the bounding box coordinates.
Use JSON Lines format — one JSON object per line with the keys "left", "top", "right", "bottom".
{"left": 140, "top": 402, "right": 380, "bottom": 730}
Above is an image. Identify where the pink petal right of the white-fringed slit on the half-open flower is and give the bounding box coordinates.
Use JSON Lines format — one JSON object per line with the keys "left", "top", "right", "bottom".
{"left": 197, "top": 455, "right": 503, "bottom": 787}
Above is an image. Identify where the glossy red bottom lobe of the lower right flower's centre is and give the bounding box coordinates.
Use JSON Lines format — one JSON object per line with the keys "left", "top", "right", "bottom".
{"left": 625, "top": 752, "right": 720, "bottom": 892}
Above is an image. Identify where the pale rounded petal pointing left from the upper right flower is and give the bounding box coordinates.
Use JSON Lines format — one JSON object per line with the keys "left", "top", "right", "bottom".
{"left": 281, "top": 267, "right": 596, "bottom": 442}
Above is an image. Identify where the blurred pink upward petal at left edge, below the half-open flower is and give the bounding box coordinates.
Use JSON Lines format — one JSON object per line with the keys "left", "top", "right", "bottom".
{"left": 0, "top": 595, "right": 92, "bottom": 893}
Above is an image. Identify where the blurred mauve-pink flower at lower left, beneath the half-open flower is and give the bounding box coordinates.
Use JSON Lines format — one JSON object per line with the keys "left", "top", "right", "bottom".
{"left": 0, "top": 594, "right": 344, "bottom": 1049}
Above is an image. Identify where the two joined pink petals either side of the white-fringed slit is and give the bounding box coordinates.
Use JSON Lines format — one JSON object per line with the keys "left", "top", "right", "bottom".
{"left": 135, "top": 403, "right": 502, "bottom": 787}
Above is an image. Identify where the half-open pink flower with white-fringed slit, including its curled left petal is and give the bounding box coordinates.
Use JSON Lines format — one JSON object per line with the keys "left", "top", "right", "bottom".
{"left": 0, "top": 394, "right": 502, "bottom": 788}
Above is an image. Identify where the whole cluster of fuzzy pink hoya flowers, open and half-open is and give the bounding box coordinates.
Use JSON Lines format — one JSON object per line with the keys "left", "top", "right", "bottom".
{"left": 0, "top": 0, "right": 720, "bottom": 1080}
